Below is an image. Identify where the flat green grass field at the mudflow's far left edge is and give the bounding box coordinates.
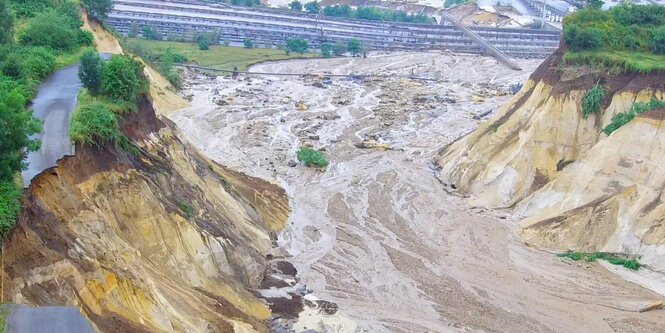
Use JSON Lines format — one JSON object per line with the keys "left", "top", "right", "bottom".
{"left": 129, "top": 38, "right": 320, "bottom": 71}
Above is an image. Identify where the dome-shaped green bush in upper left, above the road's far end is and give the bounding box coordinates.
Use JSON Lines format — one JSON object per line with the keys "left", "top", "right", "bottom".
{"left": 19, "top": 10, "right": 79, "bottom": 50}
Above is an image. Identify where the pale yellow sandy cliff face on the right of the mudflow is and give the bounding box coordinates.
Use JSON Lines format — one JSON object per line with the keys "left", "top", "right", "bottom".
{"left": 437, "top": 50, "right": 665, "bottom": 266}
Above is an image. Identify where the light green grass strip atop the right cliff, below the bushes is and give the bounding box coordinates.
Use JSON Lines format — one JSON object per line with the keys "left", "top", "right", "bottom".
{"left": 563, "top": 51, "right": 665, "bottom": 74}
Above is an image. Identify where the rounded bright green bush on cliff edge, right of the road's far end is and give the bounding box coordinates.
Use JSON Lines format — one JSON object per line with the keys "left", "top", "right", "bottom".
{"left": 102, "top": 54, "right": 148, "bottom": 104}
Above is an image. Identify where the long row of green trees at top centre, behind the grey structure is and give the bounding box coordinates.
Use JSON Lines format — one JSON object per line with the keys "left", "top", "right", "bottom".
{"left": 323, "top": 5, "right": 435, "bottom": 24}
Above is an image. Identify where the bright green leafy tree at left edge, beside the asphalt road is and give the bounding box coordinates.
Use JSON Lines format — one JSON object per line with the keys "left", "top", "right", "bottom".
{"left": 0, "top": 83, "right": 41, "bottom": 181}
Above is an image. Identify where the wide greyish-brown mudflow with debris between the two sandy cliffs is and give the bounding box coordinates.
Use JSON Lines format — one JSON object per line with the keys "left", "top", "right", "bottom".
{"left": 170, "top": 53, "right": 665, "bottom": 332}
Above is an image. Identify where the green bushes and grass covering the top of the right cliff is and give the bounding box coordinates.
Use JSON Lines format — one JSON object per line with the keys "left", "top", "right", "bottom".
{"left": 563, "top": 4, "right": 665, "bottom": 73}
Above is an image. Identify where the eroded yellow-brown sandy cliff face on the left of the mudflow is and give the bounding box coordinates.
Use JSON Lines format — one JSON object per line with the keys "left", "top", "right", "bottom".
{"left": 4, "top": 99, "right": 289, "bottom": 332}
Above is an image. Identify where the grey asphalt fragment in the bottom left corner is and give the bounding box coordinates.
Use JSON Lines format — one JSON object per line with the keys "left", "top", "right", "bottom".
{"left": 5, "top": 305, "right": 95, "bottom": 333}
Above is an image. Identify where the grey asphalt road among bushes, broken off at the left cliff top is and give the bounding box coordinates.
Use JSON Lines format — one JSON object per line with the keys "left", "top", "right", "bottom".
{"left": 21, "top": 53, "right": 110, "bottom": 187}
